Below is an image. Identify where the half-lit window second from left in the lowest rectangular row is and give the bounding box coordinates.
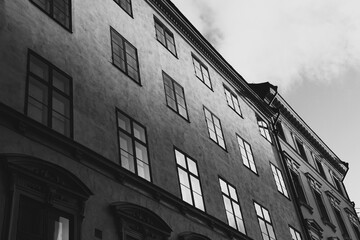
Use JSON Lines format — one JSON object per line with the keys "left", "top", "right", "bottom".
{"left": 116, "top": 109, "right": 151, "bottom": 181}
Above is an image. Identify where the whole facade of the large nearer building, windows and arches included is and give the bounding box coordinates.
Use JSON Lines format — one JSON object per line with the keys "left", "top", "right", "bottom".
{"left": 0, "top": 0, "right": 358, "bottom": 240}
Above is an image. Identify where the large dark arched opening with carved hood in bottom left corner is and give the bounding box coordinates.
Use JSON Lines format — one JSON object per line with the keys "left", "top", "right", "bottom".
{"left": 2, "top": 156, "right": 92, "bottom": 240}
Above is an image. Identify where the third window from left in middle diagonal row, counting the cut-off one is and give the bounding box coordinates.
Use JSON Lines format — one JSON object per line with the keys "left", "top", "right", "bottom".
{"left": 163, "top": 72, "right": 188, "bottom": 120}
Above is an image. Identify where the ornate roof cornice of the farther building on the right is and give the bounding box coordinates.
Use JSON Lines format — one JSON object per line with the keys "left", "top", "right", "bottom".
{"left": 272, "top": 94, "right": 348, "bottom": 176}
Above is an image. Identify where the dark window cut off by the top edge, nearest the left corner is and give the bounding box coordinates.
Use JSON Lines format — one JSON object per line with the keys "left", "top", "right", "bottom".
{"left": 30, "top": 0, "right": 71, "bottom": 31}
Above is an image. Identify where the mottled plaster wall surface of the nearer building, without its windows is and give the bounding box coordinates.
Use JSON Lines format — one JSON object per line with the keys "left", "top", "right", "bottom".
{"left": 0, "top": 0, "right": 300, "bottom": 240}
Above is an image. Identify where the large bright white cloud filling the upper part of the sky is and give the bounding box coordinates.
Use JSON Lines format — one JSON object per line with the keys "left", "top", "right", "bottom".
{"left": 173, "top": 0, "right": 360, "bottom": 92}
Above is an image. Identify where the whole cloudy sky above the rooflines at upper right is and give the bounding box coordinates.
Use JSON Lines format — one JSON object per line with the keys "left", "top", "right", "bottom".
{"left": 171, "top": 0, "right": 360, "bottom": 212}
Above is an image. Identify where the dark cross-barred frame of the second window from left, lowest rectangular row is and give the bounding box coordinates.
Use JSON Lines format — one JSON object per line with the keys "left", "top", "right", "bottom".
{"left": 115, "top": 107, "right": 152, "bottom": 182}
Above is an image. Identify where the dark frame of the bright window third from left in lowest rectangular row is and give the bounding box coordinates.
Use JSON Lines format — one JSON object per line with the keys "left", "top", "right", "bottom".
{"left": 174, "top": 146, "right": 206, "bottom": 212}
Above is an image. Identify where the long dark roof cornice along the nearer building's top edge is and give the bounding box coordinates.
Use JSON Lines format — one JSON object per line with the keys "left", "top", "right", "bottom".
{"left": 145, "top": 0, "right": 275, "bottom": 117}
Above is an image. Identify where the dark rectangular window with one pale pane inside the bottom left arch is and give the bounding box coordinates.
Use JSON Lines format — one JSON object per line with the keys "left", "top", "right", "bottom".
{"left": 17, "top": 196, "right": 74, "bottom": 240}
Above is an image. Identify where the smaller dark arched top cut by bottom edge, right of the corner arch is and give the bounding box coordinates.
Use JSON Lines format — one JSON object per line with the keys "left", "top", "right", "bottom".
{"left": 111, "top": 202, "right": 172, "bottom": 240}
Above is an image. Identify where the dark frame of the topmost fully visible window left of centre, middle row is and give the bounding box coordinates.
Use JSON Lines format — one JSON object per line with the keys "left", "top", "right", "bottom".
{"left": 110, "top": 26, "right": 142, "bottom": 86}
